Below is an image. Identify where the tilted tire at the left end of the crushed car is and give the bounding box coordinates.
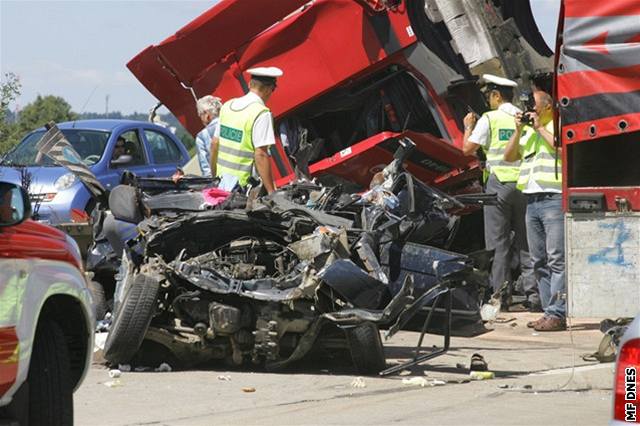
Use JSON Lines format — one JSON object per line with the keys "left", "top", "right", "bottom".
{"left": 104, "top": 273, "right": 160, "bottom": 364}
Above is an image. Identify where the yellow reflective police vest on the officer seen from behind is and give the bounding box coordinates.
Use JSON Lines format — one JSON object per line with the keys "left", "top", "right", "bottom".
{"left": 216, "top": 100, "right": 269, "bottom": 186}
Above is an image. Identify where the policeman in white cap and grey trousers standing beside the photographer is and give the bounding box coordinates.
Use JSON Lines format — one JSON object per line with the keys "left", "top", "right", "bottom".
{"left": 463, "top": 74, "right": 540, "bottom": 310}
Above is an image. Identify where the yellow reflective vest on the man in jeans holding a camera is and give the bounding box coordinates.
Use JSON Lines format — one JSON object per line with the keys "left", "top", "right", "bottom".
{"left": 517, "top": 122, "right": 562, "bottom": 191}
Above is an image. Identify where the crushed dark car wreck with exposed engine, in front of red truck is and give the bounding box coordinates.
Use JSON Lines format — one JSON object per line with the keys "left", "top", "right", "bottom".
{"left": 104, "top": 139, "right": 487, "bottom": 373}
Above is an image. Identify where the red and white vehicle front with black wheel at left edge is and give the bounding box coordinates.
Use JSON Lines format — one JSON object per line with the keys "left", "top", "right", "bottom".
{"left": 0, "top": 182, "right": 95, "bottom": 425}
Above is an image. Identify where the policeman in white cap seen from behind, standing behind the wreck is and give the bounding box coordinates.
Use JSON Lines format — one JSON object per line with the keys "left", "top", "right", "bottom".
{"left": 211, "top": 67, "right": 282, "bottom": 193}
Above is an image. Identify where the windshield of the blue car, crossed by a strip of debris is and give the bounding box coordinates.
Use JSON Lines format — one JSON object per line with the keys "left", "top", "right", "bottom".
{"left": 3, "top": 129, "right": 110, "bottom": 166}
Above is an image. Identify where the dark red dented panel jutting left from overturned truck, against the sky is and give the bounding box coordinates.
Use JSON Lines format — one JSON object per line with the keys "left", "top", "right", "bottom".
{"left": 127, "top": 0, "right": 307, "bottom": 134}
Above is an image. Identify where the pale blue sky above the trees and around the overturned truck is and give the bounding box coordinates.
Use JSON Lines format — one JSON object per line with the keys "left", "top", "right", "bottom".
{"left": 0, "top": 0, "right": 560, "bottom": 114}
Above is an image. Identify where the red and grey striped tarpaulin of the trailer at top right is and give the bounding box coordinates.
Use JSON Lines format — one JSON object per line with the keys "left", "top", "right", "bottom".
{"left": 556, "top": 0, "right": 640, "bottom": 143}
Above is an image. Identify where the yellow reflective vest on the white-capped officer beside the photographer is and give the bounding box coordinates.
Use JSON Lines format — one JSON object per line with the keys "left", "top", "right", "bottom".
{"left": 485, "top": 110, "right": 520, "bottom": 183}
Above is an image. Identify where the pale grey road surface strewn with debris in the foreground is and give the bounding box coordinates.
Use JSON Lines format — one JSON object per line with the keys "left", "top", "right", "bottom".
{"left": 75, "top": 314, "right": 613, "bottom": 426}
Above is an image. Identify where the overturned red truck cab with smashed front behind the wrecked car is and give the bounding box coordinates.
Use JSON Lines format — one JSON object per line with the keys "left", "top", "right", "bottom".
{"left": 127, "top": 0, "right": 552, "bottom": 196}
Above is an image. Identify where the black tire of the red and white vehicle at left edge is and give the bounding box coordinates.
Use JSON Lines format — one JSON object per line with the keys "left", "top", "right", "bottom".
{"left": 27, "top": 319, "right": 73, "bottom": 426}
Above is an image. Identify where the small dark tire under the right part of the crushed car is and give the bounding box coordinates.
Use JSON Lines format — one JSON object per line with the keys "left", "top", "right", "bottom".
{"left": 345, "top": 322, "right": 387, "bottom": 374}
